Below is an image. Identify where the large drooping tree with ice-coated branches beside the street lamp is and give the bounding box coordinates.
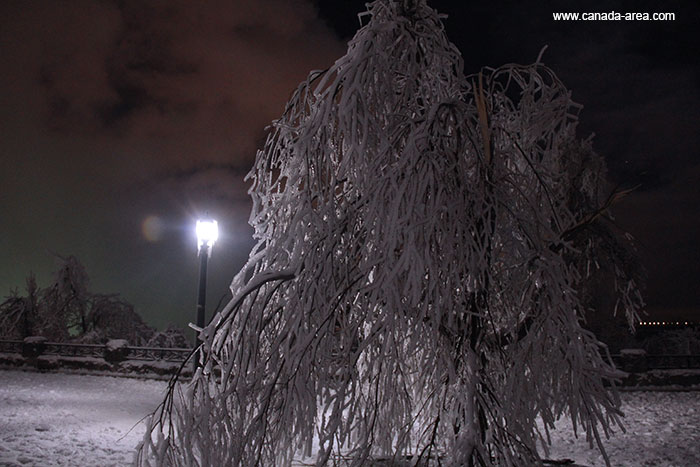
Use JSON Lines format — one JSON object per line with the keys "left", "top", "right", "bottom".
{"left": 138, "top": 0, "right": 641, "bottom": 466}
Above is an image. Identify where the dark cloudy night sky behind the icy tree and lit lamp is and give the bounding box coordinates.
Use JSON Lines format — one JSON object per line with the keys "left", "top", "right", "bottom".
{"left": 0, "top": 0, "right": 700, "bottom": 327}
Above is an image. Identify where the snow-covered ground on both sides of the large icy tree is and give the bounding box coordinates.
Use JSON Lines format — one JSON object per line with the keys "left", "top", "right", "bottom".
{"left": 0, "top": 371, "right": 700, "bottom": 467}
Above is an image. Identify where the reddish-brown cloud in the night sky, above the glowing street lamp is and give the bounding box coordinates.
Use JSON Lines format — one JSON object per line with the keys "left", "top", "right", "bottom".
{"left": 3, "top": 0, "right": 344, "bottom": 177}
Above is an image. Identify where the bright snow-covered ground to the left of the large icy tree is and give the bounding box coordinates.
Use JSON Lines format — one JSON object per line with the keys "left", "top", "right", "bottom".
{"left": 0, "top": 371, "right": 167, "bottom": 467}
